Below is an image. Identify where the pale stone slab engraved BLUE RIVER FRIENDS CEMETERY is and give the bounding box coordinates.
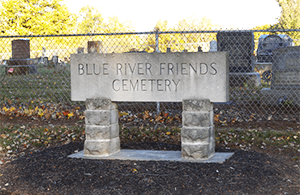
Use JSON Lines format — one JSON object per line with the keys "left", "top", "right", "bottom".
{"left": 71, "top": 52, "right": 229, "bottom": 102}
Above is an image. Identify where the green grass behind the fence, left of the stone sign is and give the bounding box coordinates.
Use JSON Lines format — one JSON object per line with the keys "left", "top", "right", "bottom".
{"left": 0, "top": 66, "right": 71, "bottom": 103}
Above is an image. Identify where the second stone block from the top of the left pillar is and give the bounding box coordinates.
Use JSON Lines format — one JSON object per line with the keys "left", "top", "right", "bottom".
{"left": 85, "top": 110, "right": 111, "bottom": 125}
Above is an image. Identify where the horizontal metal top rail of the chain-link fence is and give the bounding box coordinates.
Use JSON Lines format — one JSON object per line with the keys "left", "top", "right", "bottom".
{"left": 0, "top": 29, "right": 300, "bottom": 38}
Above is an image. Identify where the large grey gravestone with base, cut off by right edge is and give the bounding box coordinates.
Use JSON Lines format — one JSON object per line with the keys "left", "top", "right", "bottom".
{"left": 261, "top": 46, "right": 300, "bottom": 105}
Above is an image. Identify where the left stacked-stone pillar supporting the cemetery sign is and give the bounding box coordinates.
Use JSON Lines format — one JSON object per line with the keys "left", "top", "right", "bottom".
{"left": 84, "top": 99, "right": 120, "bottom": 156}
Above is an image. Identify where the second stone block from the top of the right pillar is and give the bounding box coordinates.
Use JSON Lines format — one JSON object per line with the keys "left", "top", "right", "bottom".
{"left": 182, "top": 111, "right": 213, "bottom": 127}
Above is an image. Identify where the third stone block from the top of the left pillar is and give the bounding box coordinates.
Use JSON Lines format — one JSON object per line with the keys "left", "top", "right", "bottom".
{"left": 85, "top": 124, "right": 119, "bottom": 140}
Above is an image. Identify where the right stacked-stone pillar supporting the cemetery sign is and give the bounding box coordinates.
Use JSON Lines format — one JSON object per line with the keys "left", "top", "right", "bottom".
{"left": 181, "top": 99, "right": 215, "bottom": 160}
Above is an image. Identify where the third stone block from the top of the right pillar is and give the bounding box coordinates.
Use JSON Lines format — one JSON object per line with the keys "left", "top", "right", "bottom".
{"left": 181, "top": 127, "right": 213, "bottom": 143}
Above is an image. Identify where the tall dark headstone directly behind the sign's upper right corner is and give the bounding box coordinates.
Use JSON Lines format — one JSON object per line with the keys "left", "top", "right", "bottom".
{"left": 217, "top": 31, "right": 254, "bottom": 73}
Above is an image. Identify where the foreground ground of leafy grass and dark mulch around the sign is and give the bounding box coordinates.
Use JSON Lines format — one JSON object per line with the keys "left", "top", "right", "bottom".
{"left": 0, "top": 115, "right": 300, "bottom": 194}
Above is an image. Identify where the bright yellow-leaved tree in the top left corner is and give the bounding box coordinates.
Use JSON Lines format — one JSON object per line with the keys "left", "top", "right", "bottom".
{"left": 0, "top": 0, "right": 75, "bottom": 35}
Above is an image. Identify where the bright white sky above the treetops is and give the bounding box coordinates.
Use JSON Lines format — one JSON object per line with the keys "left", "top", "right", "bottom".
{"left": 63, "top": 0, "right": 281, "bottom": 32}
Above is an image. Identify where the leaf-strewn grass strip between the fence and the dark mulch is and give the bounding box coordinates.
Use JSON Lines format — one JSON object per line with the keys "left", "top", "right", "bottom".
{"left": 0, "top": 124, "right": 300, "bottom": 160}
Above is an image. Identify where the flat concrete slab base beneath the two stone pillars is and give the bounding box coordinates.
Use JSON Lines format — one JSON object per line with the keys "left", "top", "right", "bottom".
{"left": 68, "top": 150, "right": 234, "bottom": 163}
